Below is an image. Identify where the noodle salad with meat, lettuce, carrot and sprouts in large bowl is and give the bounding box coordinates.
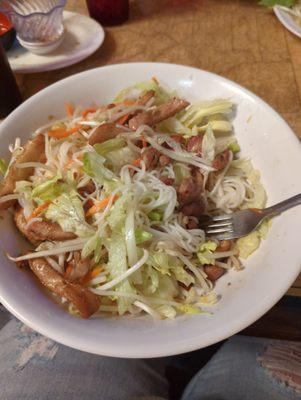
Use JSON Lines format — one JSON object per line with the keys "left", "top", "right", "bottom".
{"left": 0, "top": 78, "right": 267, "bottom": 319}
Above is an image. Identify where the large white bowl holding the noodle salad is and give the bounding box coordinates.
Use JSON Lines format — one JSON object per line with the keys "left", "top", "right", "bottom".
{"left": 0, "top": 63, "right": 301, "bottom": 357}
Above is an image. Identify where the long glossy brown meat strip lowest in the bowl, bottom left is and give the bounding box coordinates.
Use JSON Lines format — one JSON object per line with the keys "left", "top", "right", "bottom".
{"left": 29, "top": 258, "right": 100, "bottom": 318}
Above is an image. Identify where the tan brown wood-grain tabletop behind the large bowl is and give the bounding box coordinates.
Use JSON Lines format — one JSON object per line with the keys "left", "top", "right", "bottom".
{"left": 14, "top": 0, "right": 301, "bottom": 296}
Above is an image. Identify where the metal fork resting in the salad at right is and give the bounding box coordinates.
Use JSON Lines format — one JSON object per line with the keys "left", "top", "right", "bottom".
{"left": 200, "top": 193, "right": 301, "bottom": 240}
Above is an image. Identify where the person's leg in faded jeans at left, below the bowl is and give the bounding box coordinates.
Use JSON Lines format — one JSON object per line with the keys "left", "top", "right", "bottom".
{"left": 0, "top": 310, "right": 168, "bottom": 400}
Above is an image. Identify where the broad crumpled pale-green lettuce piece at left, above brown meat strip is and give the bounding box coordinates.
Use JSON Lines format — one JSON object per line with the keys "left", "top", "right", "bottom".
{"left": 45, "top": 190, "right": 94, "bottom": 237}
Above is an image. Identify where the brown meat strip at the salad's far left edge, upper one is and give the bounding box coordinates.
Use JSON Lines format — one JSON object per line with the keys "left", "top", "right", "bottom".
{"left": 0, "top": 135, "right": 46, "bottom": 209}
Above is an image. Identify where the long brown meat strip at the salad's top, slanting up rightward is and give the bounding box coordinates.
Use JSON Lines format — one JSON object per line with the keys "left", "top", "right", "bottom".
{"left": 129, "top": 97, "right": 189, "bottom": 131}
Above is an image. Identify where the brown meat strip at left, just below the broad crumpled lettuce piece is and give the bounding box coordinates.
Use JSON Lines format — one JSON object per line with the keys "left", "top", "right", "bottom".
{"left": 14, "top": 207, "right": 77, "bottom": 245}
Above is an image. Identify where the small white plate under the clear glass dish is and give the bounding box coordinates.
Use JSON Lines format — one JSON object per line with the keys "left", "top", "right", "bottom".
{"left": 7, "top": 11, "right": 105, "bottom": 73}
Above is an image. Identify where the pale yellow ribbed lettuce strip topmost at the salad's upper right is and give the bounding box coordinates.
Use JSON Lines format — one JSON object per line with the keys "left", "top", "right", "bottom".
{"left": 181, "top": 100, "right": 233, "bottom": 128}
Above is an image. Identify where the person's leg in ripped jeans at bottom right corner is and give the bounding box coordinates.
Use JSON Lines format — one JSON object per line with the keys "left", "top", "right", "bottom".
{"left": 182, "top": 336, "right": 301, "bottom": 400}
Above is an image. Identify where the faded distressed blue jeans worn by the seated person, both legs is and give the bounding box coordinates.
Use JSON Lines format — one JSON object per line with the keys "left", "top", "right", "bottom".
{"left": 0, "top": 308, "right": 301, "bottom": 400}
